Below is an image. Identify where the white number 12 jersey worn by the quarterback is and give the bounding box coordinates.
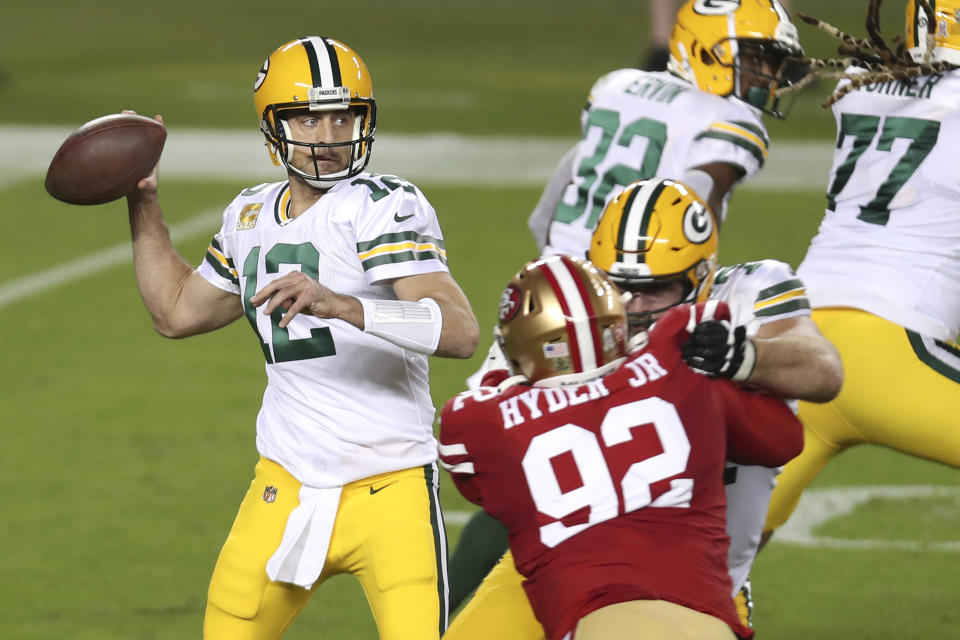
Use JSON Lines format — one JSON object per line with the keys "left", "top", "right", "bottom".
{"left": 198, "top": 173, "right": 447, "bottom": 488}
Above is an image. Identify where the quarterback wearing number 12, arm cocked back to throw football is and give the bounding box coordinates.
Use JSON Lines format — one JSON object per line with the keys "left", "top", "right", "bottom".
{"left": 128, "top": 37, "right": 478, "bottom": 640}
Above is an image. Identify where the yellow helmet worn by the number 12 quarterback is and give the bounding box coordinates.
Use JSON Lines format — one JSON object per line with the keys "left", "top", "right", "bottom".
{"left": 253, "top": 36, "right": 377, "bottom": 188}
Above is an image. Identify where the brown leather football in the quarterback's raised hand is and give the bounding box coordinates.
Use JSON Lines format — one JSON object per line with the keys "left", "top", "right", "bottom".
{"left": 45, "top": 113, "right": 167, "bottom": 205}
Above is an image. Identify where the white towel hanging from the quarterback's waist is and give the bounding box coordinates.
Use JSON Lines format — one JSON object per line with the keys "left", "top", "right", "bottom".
{"left": 267, "top": 486, "right": 342, "bottom": 589}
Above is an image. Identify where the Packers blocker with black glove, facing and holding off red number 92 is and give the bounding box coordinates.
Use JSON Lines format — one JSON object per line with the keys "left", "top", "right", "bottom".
{"left": 446, "top": 179, "right": 843, "bottom": 640}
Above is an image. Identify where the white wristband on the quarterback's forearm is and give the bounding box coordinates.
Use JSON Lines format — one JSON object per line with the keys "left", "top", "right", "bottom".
{"left": 358, "top": 298, "right": 443, "bottom": 356}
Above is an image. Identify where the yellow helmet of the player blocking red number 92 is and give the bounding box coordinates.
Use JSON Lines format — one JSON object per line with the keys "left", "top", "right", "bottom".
{"left": 587, "top": 178, "right": 718, "bottom": 326}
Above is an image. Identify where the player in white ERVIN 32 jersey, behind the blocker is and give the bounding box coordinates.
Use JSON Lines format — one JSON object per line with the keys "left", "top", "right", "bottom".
{"left": 450, "top": 0, "right": 803, "bottom": 608}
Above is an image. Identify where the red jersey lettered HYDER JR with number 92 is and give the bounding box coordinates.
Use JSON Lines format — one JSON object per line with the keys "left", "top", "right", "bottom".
{"left": 440, "top": 307, "right": 803, "bottom": 640}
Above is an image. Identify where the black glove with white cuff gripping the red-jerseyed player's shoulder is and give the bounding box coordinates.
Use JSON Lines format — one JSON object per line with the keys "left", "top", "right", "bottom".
{"left": 681, "top": 320, "right": 757, "bottom": 382}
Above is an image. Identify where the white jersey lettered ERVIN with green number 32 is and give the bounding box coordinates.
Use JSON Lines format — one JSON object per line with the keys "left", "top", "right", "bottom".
{"left": 543, "top": 69, "right": 769, "bottom": 256}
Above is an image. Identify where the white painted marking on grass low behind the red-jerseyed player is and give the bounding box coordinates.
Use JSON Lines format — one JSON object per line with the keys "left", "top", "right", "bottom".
{"left": 443, "top": 486, "right": 960, "bottom": 552}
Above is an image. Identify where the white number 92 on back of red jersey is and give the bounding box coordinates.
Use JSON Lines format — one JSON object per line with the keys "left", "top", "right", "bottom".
{"left": 522, "top": 398, "right": 693, "bottom": 548}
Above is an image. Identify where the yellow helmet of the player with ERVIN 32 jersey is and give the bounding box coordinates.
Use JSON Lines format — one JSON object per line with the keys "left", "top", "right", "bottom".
{"left": 667, "top": 0, "right": 806, "bottom": 118}
